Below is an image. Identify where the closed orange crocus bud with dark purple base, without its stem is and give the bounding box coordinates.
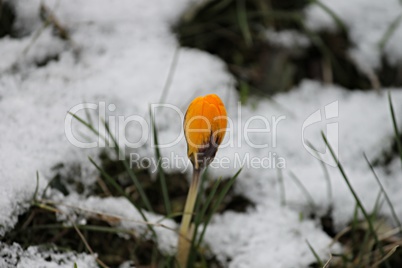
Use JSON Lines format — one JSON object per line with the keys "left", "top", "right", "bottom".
{"left": 183, "top": 94, "right": 227, "bottom": 169}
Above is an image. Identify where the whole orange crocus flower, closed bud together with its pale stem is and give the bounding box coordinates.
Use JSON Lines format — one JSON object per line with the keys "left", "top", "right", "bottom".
{"left": 176, "top": 94, "right": 227, "bottom": 268}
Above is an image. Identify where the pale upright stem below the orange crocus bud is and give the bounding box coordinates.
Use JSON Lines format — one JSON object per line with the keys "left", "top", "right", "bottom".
{"left": 176, "top": 168, "right": 201, "bottom": 268}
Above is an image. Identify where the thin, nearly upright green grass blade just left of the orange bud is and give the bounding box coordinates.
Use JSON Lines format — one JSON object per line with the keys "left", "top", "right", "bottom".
{"left": 149, "top": 108, "right": 172, "bottom": 215}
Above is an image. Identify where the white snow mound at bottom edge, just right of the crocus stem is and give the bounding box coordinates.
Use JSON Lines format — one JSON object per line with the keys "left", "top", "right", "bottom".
{"left": 206, "top": 206, "right": 339, "bottom": 268}
